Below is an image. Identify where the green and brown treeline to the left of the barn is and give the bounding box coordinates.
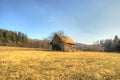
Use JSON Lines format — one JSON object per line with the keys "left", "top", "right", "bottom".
{"left": 0, "top": 29, "right": 51, "bottom": 49}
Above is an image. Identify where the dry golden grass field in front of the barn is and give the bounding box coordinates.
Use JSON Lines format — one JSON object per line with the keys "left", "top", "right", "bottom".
{"left": 0, "top": 47, "right": 120, "bottom": 80}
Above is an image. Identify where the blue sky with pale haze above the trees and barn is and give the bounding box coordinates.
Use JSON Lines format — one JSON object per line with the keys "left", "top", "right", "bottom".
{"left": 0, "top": 0, "right": 120, "bottom": 44}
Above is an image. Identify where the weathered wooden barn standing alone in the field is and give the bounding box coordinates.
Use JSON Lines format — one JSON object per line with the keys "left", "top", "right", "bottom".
{"left": 50, "top": 34, "right": 76, "bottom": 51}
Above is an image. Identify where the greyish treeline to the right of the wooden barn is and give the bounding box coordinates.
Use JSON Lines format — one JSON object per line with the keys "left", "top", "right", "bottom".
{"left": 77, "top": 35, "right": 120, "bottom": 52}
